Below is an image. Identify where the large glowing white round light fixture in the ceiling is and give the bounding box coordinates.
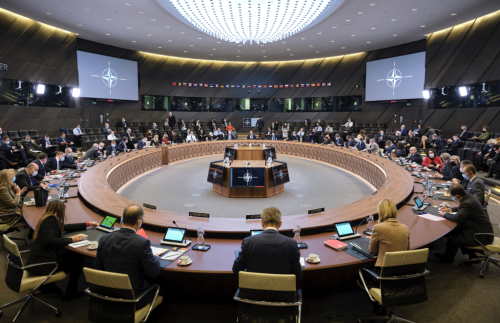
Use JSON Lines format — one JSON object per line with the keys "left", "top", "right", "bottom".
{"left": 170, "top": 0, "right": 330, "bottom": 44}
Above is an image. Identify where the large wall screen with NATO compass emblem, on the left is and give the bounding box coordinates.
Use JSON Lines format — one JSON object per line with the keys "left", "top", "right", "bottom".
{"left": 76, "top": 51, "right": 139, "bottom": 101}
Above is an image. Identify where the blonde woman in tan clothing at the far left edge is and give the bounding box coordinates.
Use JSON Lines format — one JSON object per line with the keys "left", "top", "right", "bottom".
{"left": 0, "top": 169, "right": 28, "bottom": 224}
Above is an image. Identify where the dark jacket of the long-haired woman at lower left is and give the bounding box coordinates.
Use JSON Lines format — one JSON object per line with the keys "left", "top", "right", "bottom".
{"left": 26, "top": 216, "right": 86, "bottom": 275}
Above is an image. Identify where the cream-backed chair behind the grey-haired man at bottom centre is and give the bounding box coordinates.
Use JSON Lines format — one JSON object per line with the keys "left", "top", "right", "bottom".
{"left": 233, "top": 271, "right": 302, "bottom": 323}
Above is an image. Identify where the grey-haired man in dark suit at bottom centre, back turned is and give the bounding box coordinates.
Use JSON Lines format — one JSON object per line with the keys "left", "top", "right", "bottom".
{"left": 233, "top": 207, "right": 302, "bottom": 281}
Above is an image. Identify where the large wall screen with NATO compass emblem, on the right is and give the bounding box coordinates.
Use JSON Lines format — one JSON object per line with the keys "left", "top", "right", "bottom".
{"left": 365, "top": 52, "right": 425, "bottom": 101}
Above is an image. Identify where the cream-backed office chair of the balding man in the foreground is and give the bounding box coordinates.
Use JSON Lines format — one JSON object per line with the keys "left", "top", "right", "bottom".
{"left": 83, "top": 268, "right": 163, "bottom": 323}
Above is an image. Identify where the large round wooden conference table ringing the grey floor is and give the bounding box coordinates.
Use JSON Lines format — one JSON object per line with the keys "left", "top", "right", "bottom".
{"left": 23, "top": 140, "right": 456, "bottom": 297}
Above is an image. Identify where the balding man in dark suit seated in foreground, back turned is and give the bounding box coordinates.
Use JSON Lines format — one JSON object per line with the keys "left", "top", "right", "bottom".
{"left": 94, "top": 205, "right": 161, "bottom": 309}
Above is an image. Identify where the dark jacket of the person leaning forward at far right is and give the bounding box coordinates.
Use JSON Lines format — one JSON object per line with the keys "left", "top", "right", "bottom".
{"left": 444, "top": 193, "right": 493, "bottom": 246}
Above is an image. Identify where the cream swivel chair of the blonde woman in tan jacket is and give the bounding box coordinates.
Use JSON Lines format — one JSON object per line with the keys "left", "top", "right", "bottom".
{"left": 359, "top": 248, "right": 429, "bottom": 323}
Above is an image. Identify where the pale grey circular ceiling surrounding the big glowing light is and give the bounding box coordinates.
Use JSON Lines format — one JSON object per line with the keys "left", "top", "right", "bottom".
{"left": 1, "top": 0, "right": 500, "bottom": 62}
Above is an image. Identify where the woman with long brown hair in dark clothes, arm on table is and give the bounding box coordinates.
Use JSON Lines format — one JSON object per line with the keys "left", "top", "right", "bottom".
{"left": 26, "top": 201, "right": 99, "bottom": 301}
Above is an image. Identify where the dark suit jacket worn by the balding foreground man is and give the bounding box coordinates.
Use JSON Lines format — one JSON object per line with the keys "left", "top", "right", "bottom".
{"left": 94, "top": 228, "right": 161, "bottom": 297}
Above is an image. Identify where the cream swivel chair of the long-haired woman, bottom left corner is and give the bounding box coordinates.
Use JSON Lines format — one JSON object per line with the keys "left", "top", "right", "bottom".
{"left": 0, "top": 235, "right": 66, "bottom": 322}
